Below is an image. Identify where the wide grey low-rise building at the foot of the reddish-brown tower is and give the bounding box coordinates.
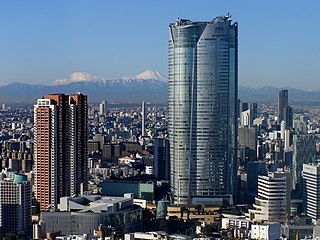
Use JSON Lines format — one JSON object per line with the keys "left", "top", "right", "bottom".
{"left": 41, "top": 194, "right": 142, "bottom": 235}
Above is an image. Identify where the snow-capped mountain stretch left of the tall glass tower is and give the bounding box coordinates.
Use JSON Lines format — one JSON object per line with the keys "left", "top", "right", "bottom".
{"left": 0, "top": 70, "right": 168, "bottom": 103}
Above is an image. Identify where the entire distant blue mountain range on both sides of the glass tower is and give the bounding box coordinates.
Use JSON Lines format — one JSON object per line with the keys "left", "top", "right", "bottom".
{"left": 0, "top": 71, "right": 320, "bottom": 103}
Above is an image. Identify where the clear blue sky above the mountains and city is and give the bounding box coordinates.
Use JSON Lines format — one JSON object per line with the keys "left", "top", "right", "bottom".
{"left": 0, "top": 0, "right": 320, "bottom": 89}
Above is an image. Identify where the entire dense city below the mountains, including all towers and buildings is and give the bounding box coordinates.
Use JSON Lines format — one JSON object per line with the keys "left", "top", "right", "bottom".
{"left": 0, "top": 10, "right": 320, "bottom": 240}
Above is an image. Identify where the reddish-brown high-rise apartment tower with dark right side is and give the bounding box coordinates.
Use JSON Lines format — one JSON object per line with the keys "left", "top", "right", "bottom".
{"left": 34, "top": 93, "right": 88, "bottom": 211}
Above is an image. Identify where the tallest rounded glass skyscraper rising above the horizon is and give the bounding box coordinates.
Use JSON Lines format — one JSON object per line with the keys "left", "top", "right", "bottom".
{"left": 169, "top": 15, "right": 238, "bottom": 204}
